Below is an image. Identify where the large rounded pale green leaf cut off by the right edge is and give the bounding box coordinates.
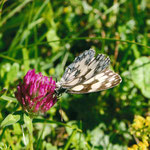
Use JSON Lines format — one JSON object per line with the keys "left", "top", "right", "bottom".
{"left": 130, "top": 57, "right": 150, "bottom": 98}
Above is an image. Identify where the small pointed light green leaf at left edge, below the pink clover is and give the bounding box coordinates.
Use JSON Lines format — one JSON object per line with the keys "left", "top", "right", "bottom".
{"left": 1, "top": 114, "right": 20, "bottom": 127}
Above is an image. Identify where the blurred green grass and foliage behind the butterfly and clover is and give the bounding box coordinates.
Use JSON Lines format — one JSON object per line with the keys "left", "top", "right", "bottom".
{"left": 0, "top": 0, "right": 150, "bottom": 150}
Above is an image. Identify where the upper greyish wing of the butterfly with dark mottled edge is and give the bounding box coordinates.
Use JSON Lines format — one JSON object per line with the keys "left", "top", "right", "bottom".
{"left": 62, "top": 50, "right": 110, "bottom": 88}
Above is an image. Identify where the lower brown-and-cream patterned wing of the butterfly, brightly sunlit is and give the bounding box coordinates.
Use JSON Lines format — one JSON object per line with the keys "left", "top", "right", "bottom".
{"left": 68, "top": 69, "right": 121, "bottom": 94}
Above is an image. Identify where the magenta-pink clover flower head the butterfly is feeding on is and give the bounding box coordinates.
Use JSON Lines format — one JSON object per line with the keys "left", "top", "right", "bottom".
{"left": 15, "top": 69, "right": 57, "bottom": 113}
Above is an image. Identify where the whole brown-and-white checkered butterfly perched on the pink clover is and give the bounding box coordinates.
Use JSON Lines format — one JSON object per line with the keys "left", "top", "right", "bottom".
{"left": 56, "top": 49, "right": 122, "bottom": 94}
